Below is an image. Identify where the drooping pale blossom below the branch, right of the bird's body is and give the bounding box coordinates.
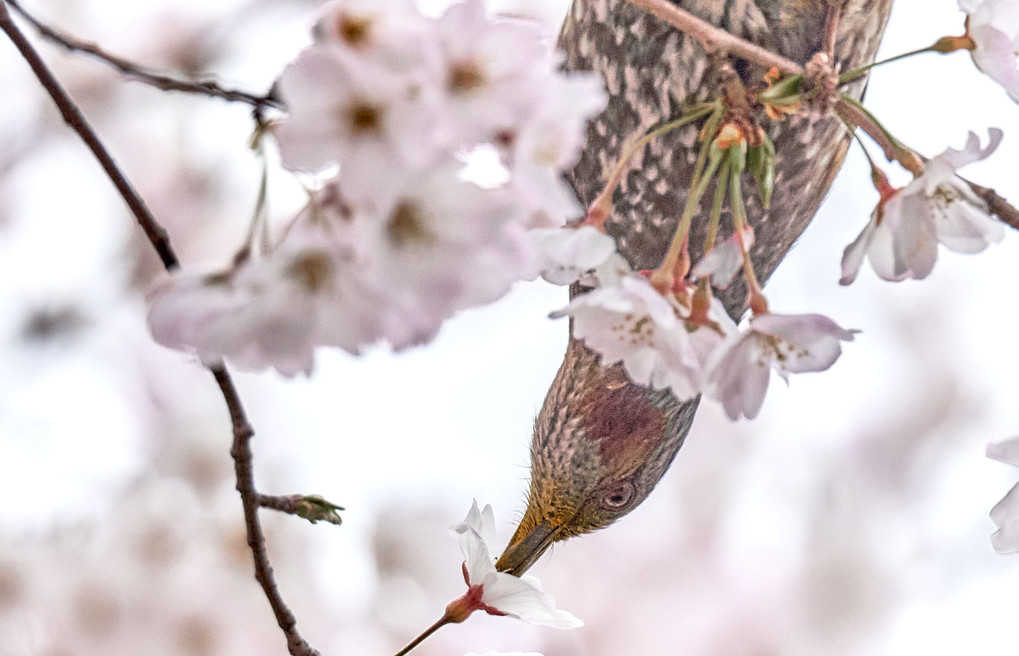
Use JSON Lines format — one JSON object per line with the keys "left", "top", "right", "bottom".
{"left": 840, "top": 128, "right": 1005, "bottom": 284}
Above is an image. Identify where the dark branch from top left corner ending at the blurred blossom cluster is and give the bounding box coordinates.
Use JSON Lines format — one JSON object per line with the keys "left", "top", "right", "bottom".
{"left": 7, "top": 0, "right": 281, "bottom": 109}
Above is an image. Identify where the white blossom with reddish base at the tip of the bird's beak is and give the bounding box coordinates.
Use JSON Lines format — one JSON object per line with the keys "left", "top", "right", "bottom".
{"left": 445, "top": 501, "right": 584, "bottom": 628}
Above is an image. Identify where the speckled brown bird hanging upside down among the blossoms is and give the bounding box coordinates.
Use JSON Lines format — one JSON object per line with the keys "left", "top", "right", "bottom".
{"left": 495, "top": 0, "right": 893, "bottom": 576}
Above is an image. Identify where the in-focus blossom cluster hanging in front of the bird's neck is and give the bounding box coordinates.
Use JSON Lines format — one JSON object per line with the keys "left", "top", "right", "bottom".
{"left": 561, "top": 251, "right": 856, "bottom": 420}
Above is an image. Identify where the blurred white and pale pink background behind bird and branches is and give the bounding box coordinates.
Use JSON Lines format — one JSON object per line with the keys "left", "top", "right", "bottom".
{"left": 0, "top": 0, "right": 1019, "bottom": 656}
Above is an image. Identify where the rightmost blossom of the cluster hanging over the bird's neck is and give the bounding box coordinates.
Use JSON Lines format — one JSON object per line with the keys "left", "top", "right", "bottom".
{"left": 704, "top": 314, "right": 856, "bottom": 421}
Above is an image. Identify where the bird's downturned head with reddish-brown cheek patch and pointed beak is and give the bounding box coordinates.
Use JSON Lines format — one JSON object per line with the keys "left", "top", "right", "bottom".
{"left": 495, "top": 341, "right": 697, "bottom": 575}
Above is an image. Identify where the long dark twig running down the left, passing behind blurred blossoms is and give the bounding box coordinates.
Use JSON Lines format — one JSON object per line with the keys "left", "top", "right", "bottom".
{"left": 0, "top": 1, "right": 318, "bottom": 656}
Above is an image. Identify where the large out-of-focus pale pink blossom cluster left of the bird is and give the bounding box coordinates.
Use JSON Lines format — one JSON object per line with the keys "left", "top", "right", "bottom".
{"left": 143, "top": 0, "right": 612, "bottom": 376}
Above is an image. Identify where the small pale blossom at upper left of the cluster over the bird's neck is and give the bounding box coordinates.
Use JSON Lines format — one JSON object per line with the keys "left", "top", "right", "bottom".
{"left": 527, "top": 225, "right": 615, "bottom": 285}
